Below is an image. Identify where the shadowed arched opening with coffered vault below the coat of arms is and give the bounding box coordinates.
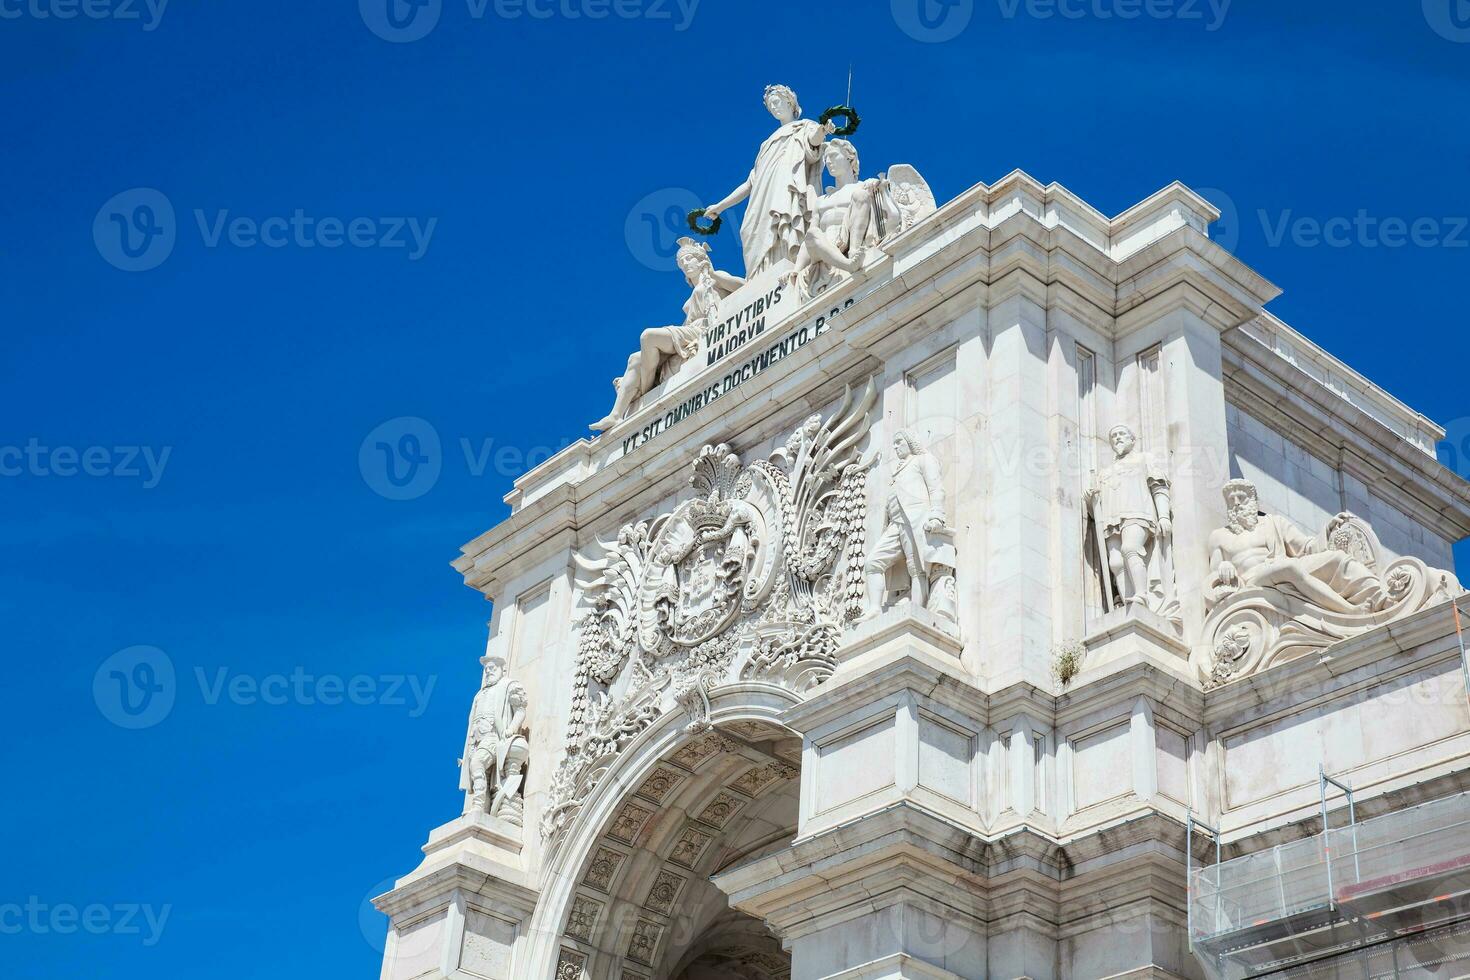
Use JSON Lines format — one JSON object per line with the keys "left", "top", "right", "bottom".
{"left": 556, "top": 718, "right": 801, "bottom": 980}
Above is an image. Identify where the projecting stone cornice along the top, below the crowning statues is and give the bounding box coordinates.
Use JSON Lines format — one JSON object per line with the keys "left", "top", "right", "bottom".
{"left": 453, "top": 181, "right": 1277, "bottom": 595}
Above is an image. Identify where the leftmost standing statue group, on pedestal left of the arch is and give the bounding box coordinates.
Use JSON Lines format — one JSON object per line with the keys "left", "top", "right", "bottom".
{"left": 460, "top": 657, "right": 531, "bottom": 827}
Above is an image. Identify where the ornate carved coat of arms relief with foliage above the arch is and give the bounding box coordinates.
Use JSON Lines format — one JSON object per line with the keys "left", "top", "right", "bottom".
{"left": 542, "top": 381, "right": 876, "bottom": 839}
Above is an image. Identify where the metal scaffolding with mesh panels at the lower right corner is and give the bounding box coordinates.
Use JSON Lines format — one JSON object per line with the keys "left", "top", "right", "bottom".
{"left": 1186, "top": 770, "right": 1470, "bottom": 980}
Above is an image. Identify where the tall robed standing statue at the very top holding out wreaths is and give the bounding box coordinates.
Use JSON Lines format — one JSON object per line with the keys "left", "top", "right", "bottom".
{"left": 704, "top": 85, "right": 836, "bottom": 278}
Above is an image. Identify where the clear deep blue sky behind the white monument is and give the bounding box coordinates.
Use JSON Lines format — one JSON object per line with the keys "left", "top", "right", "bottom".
{"left": 0, "top": 0, "right": 1470, "bottom": 980}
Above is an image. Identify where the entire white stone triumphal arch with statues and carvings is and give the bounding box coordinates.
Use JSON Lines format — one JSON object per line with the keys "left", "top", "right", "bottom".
{"left": 376, "top": 85, "right": 1470, "bottom": 980}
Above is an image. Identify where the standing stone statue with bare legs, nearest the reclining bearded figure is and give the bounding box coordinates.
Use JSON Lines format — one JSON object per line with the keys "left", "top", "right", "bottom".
{"left": 1085, "top": 425, "right": 1182, "bottom": 629}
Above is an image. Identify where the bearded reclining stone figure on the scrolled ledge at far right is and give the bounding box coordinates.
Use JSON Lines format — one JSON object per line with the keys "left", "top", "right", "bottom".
{"left": 1205, "top": 480, "right": 1392, "bottom": 614}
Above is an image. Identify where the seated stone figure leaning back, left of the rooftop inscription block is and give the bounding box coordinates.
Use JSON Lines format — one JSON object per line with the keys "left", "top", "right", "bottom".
{"left": 591, "top": 238, "right": 745, "bottom": 432}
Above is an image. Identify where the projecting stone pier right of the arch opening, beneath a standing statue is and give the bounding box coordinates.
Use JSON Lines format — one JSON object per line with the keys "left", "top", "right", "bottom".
{"left": 714, "top": 610, "right": 988, "bottom": 980}
